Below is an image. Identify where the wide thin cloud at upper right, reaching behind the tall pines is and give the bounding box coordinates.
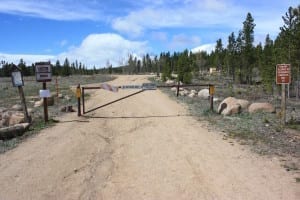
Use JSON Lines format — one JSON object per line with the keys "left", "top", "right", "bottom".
{"left": 112, "top": 0, "right": 295, "bottom": 43}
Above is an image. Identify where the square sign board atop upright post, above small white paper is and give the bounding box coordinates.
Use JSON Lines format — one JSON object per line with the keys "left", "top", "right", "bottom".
{"left": 35, "top": 62, "right": 52, "bottom": 82}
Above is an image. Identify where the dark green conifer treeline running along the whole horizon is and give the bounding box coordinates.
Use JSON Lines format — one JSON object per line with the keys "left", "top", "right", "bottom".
{"left": 0, "top": 5, "right": 300, "bottom": 91}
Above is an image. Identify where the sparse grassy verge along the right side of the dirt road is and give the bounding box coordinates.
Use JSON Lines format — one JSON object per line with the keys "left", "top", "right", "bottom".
{"left": 151, "top": 76, "right": 300, "bottom": 178}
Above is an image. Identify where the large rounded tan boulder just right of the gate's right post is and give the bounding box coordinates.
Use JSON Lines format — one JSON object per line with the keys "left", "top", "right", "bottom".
{"left": 218, "top": 97, "right": 242, "bottom": 116}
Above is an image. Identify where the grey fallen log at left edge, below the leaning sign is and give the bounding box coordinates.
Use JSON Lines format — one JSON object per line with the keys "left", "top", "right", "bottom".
{"left": 0, "top": 123, "right": 30, "bottom": 140}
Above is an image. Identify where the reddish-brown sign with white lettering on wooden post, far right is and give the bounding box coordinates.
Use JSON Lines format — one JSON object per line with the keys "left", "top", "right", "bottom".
{"left": 276, "top": 64, "right": 291, "bottom": 125}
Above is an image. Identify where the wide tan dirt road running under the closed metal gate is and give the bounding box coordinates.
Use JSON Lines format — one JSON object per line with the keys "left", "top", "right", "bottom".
{"left": 0, "top": 76, "right": 300, "bottom": 200}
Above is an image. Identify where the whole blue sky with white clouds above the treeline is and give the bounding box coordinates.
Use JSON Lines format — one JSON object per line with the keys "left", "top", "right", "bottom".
{"left": 0, "top": 0, "right": 300, "bottom": 67}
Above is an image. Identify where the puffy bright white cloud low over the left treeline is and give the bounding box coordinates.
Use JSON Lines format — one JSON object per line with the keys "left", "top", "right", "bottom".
{"left": 0, "top": 33, "right": 149, "bottom": 67}
